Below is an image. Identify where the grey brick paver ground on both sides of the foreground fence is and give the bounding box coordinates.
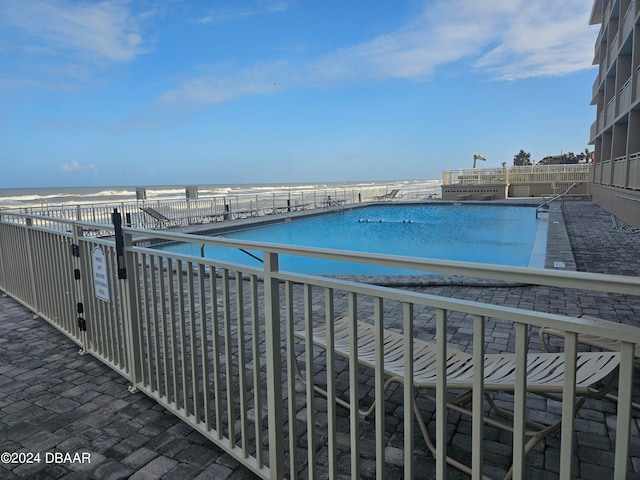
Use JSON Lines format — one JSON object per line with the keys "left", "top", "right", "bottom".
{"left": 0, "top": 201, "right": 640, "bottom": 480}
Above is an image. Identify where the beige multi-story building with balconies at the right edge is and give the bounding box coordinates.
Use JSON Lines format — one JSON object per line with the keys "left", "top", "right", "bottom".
{"left": 589, "top": 0, "right": 640, "bottom": 227}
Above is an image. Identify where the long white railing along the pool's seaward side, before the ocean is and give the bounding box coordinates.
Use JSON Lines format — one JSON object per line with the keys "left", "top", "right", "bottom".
{"left": 0, "top": 185, "right": 440, "bottom": 228}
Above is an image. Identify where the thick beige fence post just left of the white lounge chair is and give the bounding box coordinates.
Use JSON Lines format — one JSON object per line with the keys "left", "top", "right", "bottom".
{"left": 263, "top": 252, "right": 284, "bottom": 480}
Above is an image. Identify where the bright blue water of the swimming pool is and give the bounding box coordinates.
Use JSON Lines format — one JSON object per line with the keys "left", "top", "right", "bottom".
{"left": 160, "top": 205, "right": 547, "bottom": 275}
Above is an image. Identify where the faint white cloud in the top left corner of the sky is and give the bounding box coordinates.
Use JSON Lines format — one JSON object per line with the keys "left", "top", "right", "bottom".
{"left": 0, "top": 0, "right": 147, "bottom": 63}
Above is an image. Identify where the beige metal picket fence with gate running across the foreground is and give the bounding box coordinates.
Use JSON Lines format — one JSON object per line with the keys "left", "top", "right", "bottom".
{"left": 0, "top": 214, "right": 640, "bottom": 479}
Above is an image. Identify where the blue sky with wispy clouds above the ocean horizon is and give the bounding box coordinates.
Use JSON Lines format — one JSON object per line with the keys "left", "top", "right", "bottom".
{"left": 0, "top": 0, "right": 598, "bottom": 188}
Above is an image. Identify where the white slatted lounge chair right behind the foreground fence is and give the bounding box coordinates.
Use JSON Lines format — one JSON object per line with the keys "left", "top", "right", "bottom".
{"left": 294, "top": 317, "right": 620, "bottom": 478}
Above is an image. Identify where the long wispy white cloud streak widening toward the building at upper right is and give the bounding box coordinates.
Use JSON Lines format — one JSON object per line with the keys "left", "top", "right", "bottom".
{"left": 159, "top": 0, "right": 597, "bottom": 108}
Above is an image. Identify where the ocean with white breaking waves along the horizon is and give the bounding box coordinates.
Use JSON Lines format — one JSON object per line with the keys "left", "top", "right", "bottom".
{"left": 0, "top": 180, "right": 442, "bottom": 210}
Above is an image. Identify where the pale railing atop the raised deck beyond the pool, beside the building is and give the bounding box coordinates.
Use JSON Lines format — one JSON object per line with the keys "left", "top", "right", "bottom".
{"left": 442, "top": 163, "right": 591, "bottom": 185}
